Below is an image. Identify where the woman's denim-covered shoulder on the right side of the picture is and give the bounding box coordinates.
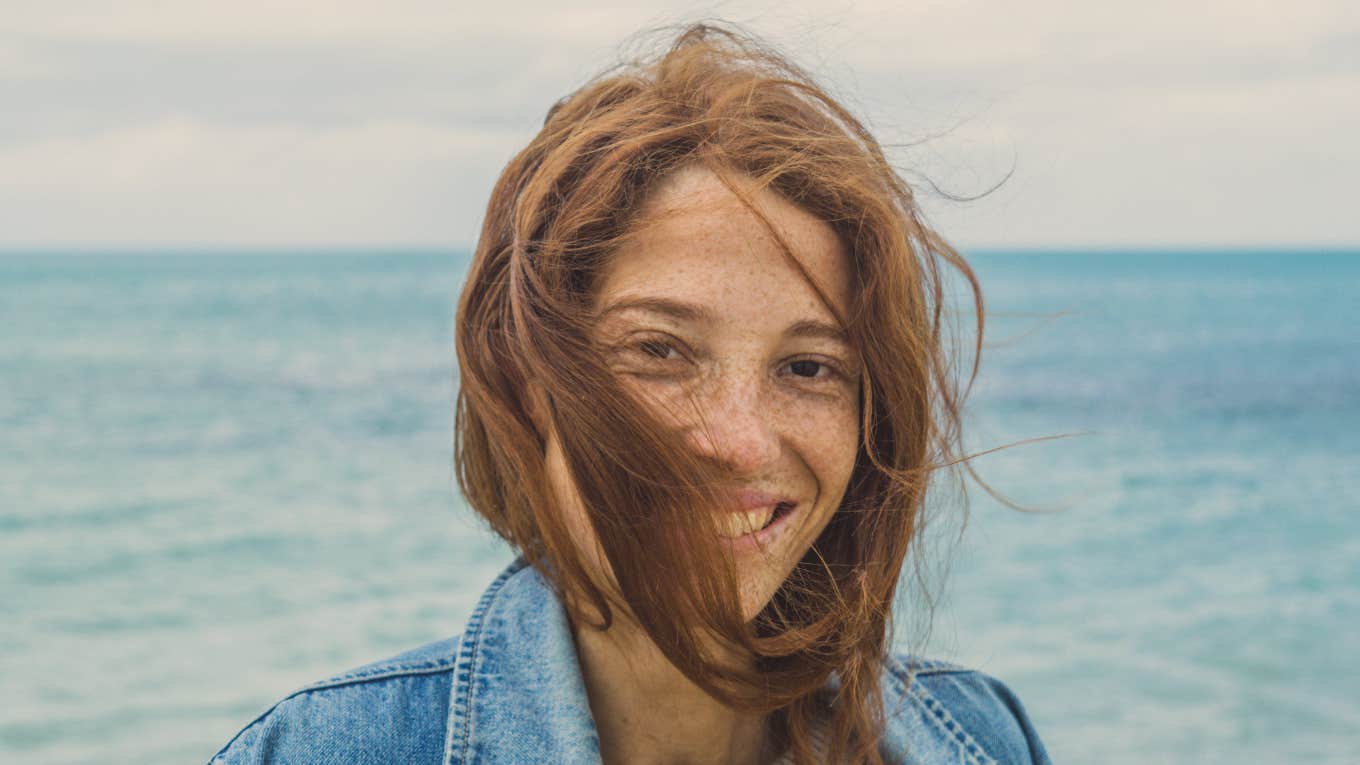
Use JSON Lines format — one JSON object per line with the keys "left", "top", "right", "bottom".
{"left": 884, "top": 653, "right": 1050, "bottom": 765}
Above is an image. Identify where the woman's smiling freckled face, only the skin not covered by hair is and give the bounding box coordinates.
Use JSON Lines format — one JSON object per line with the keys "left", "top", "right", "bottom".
{"left": 547, "top": 166, "right": 860, "bottom": 619}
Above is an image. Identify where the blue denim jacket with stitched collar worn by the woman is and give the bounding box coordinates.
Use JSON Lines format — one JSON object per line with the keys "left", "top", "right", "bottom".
{"left": 209, "top": 558, "right": 1049, "bottom": 765}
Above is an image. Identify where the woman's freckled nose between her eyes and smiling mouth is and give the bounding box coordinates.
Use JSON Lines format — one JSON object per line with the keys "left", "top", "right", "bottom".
{"left": 688, "top": 380, "right": 781, "bottom": 475}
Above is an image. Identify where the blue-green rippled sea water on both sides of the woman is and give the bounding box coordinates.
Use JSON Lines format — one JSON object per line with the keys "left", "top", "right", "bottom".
{"left": 0, "top": 250, "right": 1360, "bottom": 764}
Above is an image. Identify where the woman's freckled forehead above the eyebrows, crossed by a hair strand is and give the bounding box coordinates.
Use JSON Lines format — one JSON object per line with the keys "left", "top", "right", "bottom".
{"left": 597, "top": 166, "right": 850, "bottom": 321}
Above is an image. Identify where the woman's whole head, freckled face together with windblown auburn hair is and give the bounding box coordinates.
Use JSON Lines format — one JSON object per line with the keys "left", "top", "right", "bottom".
{"left": 456, "top": 25, "right": 982, "bottom": 762}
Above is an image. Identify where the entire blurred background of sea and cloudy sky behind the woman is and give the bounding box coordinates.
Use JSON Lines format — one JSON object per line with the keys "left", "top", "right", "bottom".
{"left": 0, "top": 0, "right": 1360, "bottom": 764}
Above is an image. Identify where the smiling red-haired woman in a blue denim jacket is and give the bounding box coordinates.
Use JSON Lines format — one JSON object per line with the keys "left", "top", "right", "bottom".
{"left": 215, "top": 25, "right": 1047, "bottom": 765}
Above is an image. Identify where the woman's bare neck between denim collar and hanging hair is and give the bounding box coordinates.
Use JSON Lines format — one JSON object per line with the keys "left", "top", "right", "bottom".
{"left": 573, "top": 618, "right": 771, "bottom": 765}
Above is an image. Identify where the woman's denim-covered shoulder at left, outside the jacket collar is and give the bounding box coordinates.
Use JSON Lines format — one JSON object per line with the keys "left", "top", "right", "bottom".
{"left": 209, "top": 637, "right": 461, "bottom": 765}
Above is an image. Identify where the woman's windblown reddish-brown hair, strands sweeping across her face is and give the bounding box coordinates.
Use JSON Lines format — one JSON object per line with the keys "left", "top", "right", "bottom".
{"left": 456, "top": 23, "right": 983, "bottom": 764}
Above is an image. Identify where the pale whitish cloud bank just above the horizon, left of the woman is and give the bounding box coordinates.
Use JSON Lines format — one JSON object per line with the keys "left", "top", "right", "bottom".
{"left": 0, "top": 118, "right": 518, "bottom": 246}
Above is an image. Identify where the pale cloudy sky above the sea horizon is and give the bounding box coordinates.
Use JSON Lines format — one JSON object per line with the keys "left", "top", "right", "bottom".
{"left": 0, "top": 0, "right": 1360, "bottom": 249}
